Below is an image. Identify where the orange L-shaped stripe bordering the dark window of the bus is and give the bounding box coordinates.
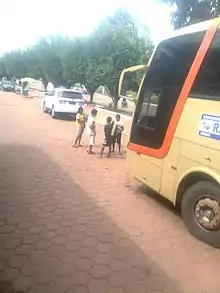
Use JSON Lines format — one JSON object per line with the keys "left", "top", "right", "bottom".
{"left": 128, "top": 21, "right": 220, "bottom": 159}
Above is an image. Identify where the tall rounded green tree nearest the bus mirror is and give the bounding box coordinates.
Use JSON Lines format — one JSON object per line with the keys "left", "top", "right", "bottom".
{"left": 93, "top": 10, "right": 153, "bottom": 109}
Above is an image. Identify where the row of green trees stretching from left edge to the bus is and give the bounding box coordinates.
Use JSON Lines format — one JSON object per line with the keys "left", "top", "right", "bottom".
{"left": 0, "top": 10, "right": 154, "bottom": 108}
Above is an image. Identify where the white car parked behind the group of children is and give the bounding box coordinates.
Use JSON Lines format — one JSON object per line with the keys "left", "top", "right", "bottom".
{"left": 43, "top": 88, "right": 85, "bottom": 118}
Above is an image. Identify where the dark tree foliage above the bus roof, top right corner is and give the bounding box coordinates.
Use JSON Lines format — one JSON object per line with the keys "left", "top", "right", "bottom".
{"left": 165, "top": 0, "right": 220, "bottom": 29}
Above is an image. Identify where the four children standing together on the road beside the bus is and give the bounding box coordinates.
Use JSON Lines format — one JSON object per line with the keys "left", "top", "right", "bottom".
{"left": 73, "top": 107, "right": 124, "bottom": 158}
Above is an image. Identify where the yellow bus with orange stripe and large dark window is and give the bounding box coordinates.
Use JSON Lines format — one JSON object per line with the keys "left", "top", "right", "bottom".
{"left": 119, "top": 18, "right": 220, "bottom": 247}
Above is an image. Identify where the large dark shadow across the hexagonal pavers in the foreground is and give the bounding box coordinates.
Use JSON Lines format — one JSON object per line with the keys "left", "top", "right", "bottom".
{"left": 0, "top": 145, "right": 180, "bottom": 293}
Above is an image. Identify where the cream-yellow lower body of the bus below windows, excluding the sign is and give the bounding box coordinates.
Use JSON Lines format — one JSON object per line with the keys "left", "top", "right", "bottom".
{"left": 127, "top": 98, "right": 220, "bottom": 204}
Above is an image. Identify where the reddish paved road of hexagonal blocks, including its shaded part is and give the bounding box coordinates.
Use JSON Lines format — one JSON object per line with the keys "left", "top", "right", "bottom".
{"left": 0, "top": 93, "right": 220, "bottom": 293}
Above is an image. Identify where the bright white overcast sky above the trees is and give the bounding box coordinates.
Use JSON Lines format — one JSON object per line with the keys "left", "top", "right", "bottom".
{"left": 0, "top": 0, "right": 175, "bottom": 54}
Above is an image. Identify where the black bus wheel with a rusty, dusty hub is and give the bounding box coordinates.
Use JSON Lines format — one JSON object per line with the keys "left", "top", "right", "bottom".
{"left": 181, "top": 181, "right": 220, "bottom": 247}
